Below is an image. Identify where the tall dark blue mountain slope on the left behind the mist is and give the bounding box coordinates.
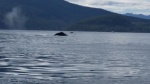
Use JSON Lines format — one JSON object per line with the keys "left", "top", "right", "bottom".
{"left": 0, "top": 0, "right": 112, "bottom": 30}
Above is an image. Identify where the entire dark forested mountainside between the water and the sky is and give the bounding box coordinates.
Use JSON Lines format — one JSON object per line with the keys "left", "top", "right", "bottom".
{"left": 0, "top": 0, "right": 150, "bottom": 32}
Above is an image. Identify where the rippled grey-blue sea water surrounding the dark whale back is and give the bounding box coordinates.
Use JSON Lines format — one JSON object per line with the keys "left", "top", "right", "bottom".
{"left": 0, "top": 30, "right": 150, "bottom": 84}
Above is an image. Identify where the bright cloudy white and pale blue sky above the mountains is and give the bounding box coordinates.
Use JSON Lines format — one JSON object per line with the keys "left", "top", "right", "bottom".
{"left": 66, "top": 0, "right": 150, "bottom": 15}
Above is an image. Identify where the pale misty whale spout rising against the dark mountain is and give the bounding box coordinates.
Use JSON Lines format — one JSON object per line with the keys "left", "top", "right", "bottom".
{"left": 5, "top": 7, "right": 27, "bottom": 29}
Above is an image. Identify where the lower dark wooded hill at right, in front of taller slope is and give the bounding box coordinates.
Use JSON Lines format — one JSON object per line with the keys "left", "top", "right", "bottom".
{"left": 68, "top": 14, "right": 150, "bottom": 32}
